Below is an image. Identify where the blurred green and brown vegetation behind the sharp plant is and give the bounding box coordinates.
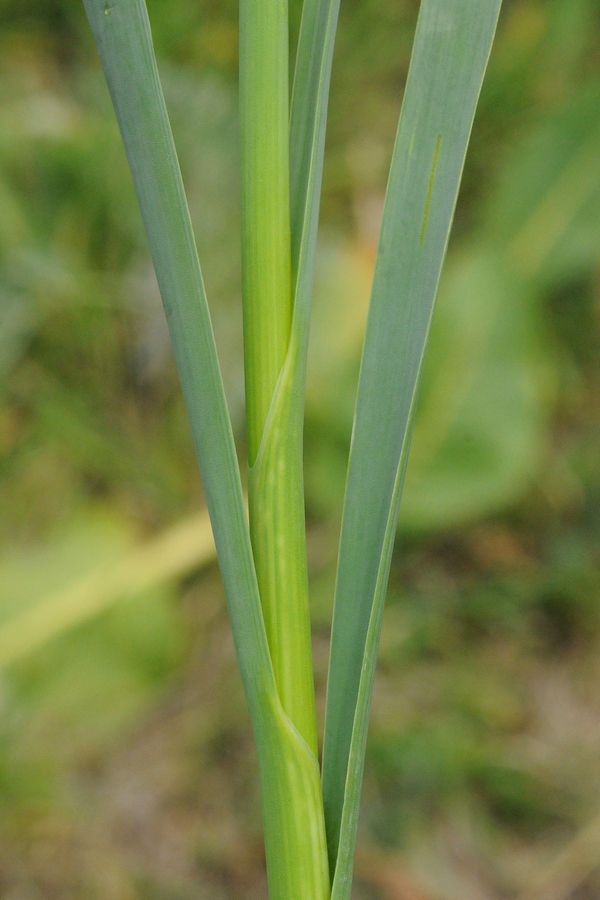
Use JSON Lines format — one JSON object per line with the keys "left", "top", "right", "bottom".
{"left": 0, "top": 0, "right": 600, "bottom": 900}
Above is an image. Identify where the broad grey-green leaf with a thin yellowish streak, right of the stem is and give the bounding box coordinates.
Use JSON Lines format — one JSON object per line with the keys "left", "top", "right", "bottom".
{"left": 323, "top": 0, "right": 501, "bottom": 888}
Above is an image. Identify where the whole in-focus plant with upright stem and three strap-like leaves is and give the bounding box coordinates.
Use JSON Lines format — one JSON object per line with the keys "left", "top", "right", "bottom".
{"left": 79, "top": 0, "right": 501, "bottom": 900}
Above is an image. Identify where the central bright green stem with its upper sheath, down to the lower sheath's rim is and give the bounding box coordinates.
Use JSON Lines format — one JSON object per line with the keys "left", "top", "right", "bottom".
{"left": 240, "top": 0, "right": 317, "bottom": 755}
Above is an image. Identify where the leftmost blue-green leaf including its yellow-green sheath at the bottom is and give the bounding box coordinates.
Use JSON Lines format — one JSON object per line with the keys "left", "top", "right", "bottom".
{"left": 84, "top": 0, "right": 329, "bottom": 900}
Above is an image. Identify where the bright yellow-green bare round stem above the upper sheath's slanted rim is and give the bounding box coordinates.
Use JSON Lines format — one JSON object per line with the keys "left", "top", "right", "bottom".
{"left": 240, "top": 0, "right": 292, "bottom": 466}
